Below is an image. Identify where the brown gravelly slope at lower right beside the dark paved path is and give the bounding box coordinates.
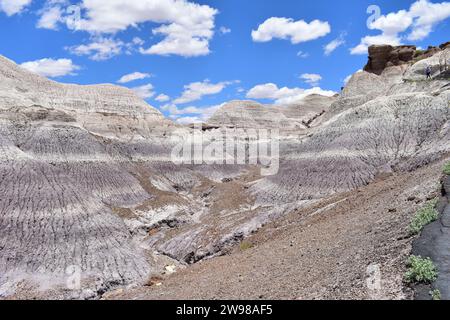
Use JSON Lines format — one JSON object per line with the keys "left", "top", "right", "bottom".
{"left": 104, "top": 162, "right": 443, "bottom": 299}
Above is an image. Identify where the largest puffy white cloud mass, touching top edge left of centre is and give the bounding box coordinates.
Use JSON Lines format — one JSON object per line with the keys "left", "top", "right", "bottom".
{"left": 58, "top": 0, "right": 218, "bottom": 57}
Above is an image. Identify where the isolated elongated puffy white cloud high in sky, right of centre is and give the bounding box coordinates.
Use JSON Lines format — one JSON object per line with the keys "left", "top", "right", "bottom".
{"left": 252, "top": 17, "right": 331, "bottom": 44}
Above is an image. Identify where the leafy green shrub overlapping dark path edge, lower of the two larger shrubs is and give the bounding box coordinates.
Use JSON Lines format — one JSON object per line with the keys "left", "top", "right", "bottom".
{"left": 405, "top": 256, "right": 438, "bottom": 283}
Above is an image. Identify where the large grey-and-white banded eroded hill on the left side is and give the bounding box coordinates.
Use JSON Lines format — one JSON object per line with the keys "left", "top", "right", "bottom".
{"left": 0, "top": 58, "right": 173, "bottom": 294}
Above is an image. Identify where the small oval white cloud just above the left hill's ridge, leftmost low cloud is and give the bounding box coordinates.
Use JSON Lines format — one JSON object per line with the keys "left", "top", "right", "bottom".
{"left": 20, "top": 58, "right": 80, "bottom": 78}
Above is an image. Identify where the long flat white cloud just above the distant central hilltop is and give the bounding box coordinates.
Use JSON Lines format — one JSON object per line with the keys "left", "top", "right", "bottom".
{"left": 247, "top": 83, "right": 336, "bottom": 104}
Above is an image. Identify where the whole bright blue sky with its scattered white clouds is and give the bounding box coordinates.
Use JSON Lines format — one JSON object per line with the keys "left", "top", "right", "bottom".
{"left": 0, "top": 0, "right": 450, "bottom": 122}
